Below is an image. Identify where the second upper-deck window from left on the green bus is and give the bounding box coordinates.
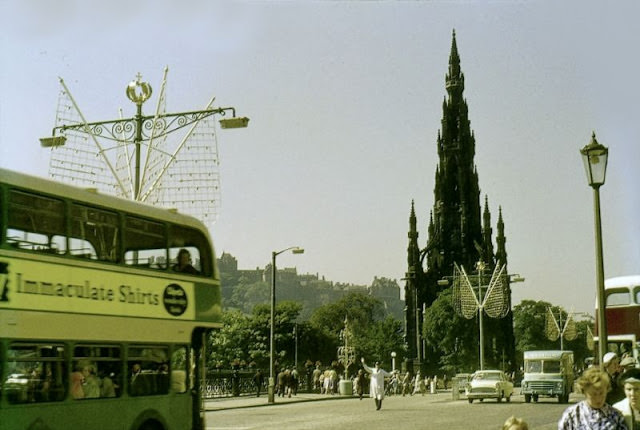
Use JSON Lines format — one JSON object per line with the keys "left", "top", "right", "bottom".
{"left": 69, "top": 204, "right": 118, "bottom": 262}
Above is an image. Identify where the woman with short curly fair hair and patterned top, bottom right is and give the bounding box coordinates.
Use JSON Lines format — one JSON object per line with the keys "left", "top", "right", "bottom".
{"left": 558, "top": 366, "right": 629, "bottom": 430}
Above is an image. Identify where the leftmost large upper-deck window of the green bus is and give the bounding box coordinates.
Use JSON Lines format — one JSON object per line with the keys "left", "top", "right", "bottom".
{"left": 7, "top": 190, "right": 66, "bottom": 254}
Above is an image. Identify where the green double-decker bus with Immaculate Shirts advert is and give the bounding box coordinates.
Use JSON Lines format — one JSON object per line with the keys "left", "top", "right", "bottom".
{"left": 0, "top": 169, "right": 222, "bottom": 430}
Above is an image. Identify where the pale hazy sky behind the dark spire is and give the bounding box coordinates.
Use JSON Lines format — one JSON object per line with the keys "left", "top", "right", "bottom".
{"left": 0, "top": 0, "right": 640, "bottom": 313}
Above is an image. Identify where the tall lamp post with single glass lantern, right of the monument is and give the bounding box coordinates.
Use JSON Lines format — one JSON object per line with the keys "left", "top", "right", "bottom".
{"left": 580, "top": 132, "right": 609, "bottom": 362}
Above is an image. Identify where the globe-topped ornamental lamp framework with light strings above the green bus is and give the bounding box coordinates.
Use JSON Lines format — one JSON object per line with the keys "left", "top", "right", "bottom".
{"left": 40, "top": 68, "right": 249, "bottom": 225}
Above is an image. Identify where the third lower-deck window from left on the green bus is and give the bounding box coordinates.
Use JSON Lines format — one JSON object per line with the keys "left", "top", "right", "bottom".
{"left": 127, "top": 346, "right": 169, "bottom": 396}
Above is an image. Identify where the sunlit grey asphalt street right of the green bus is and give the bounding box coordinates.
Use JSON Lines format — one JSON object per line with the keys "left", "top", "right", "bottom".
{"left": 206, "top": 391, "right": 568, "bottom": 430}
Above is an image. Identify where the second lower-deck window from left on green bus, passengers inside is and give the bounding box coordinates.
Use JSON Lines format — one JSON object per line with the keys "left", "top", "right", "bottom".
{"left": 70, "top": 345, "right": 122, "bottom": 399}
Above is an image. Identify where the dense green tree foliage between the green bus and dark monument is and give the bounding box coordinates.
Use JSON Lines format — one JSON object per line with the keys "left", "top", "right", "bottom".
{"left": 208, "top": 293, "right": 404, "bottom": 371}
